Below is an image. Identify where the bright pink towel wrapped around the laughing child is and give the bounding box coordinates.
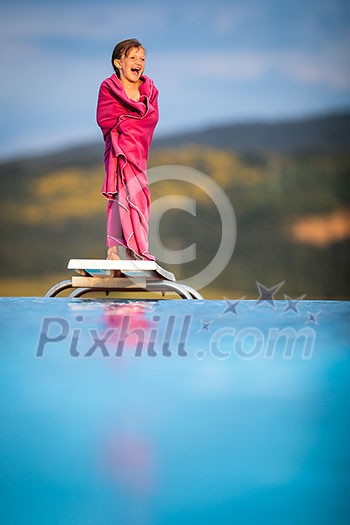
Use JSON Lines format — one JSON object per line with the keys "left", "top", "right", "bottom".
{"left": 97, "top": 74, "right": 159, "bottom": 260}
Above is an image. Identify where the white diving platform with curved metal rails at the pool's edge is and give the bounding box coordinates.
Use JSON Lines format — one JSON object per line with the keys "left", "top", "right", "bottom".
{"left": 45, "top": 259, "right": 203, "bottom": 299}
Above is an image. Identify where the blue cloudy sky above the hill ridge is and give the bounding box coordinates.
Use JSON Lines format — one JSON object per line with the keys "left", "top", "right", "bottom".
{"left": 0, "top": 0, "right": 350, "bottom": 159}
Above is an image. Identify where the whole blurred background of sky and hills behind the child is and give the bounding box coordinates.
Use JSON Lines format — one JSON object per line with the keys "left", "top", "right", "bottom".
{"left": 0, "top": 0, "right": 350, "bottom": 299}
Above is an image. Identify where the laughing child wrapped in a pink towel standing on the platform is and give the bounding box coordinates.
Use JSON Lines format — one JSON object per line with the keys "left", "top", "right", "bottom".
{"left": 97, "top": 39, "right": 159, "bottom": 260}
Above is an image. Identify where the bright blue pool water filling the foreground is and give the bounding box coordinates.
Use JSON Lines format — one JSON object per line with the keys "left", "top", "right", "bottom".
{"left": 0, "top": 298, "right": 350, "bottom": 525}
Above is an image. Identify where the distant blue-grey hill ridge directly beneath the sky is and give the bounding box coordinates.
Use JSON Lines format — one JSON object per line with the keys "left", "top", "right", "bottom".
{"left": 0, "top": 111, "right": 350, "bottom": 172}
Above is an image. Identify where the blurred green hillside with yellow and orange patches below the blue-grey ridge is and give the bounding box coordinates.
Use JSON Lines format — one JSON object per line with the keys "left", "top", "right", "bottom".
{"left": 0, "top": 137, "right": 350, "bottom": 298}
